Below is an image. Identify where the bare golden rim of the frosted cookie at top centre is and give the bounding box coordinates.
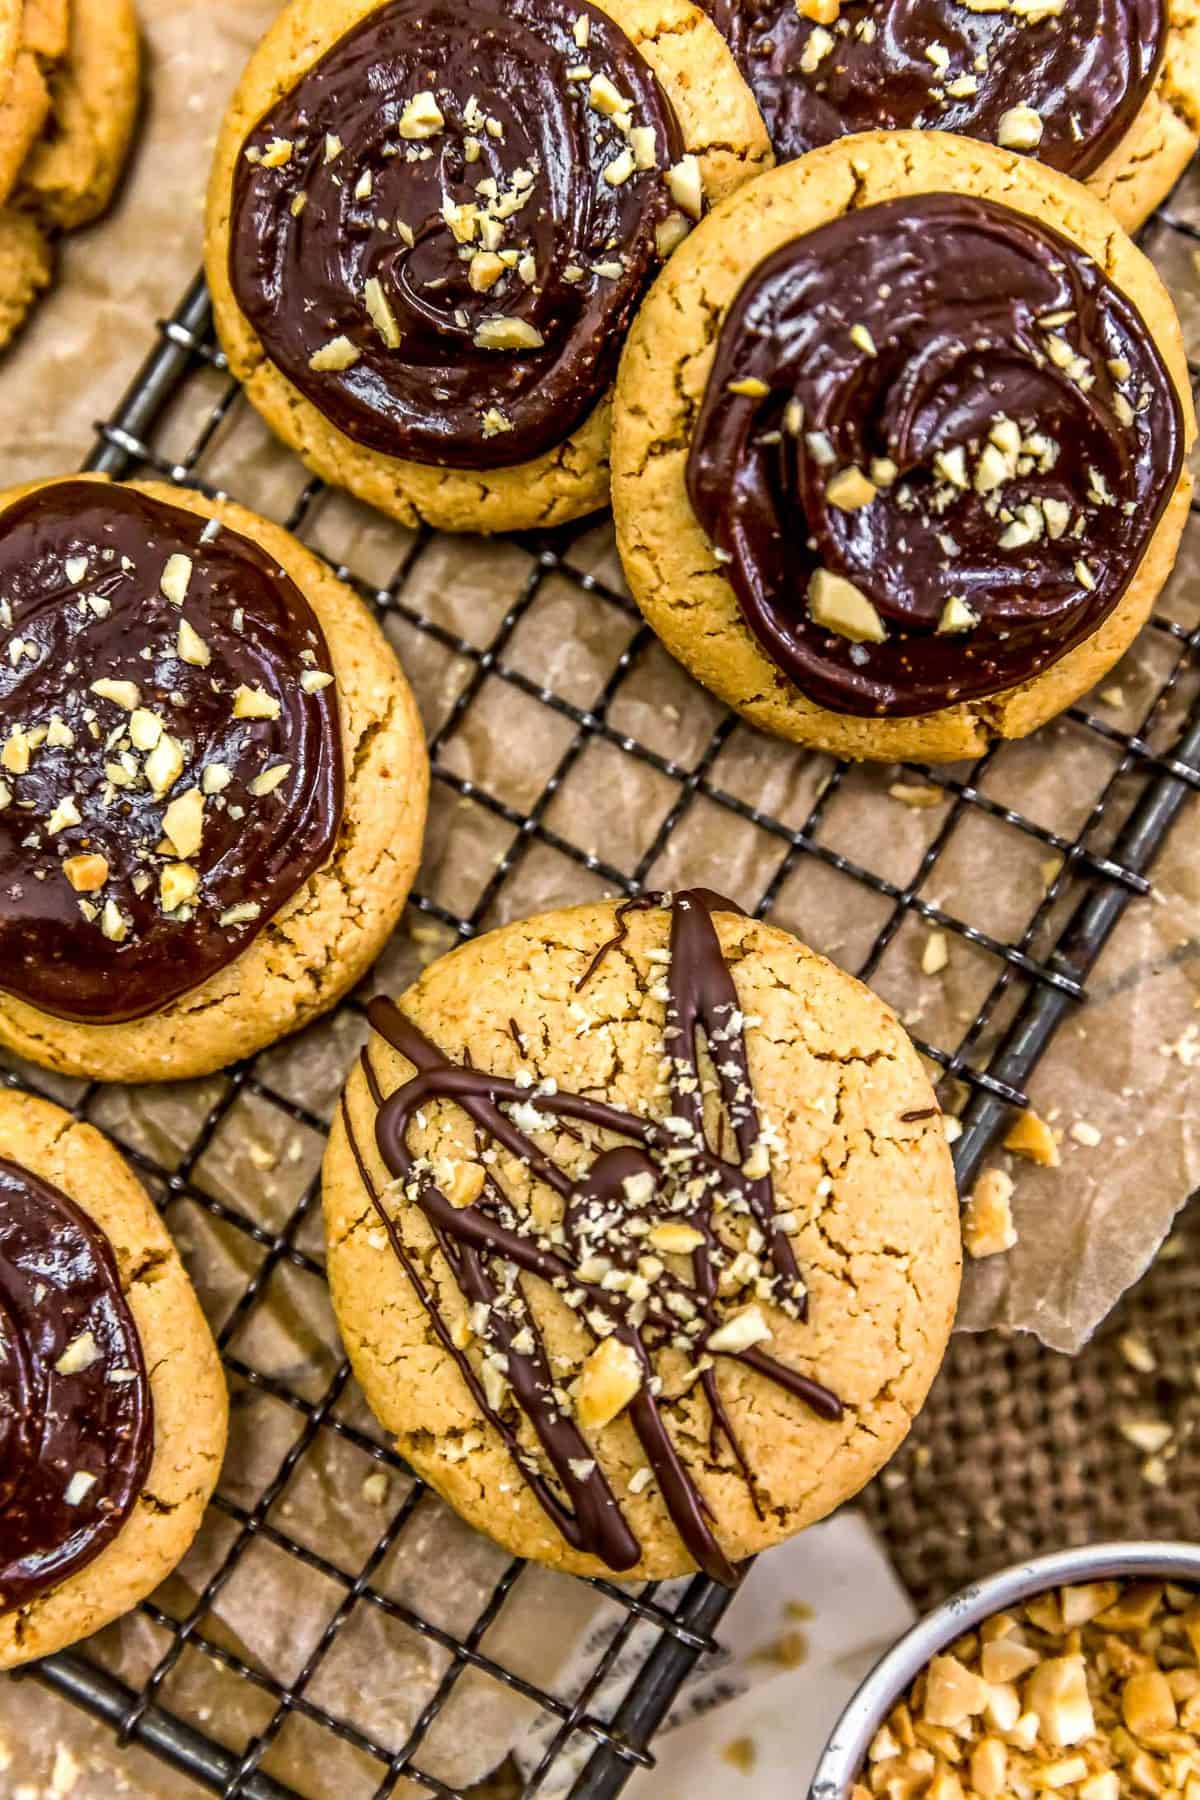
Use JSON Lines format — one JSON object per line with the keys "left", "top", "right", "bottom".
{"left": 205, "top": 0, "right": 772, "bottom": 531}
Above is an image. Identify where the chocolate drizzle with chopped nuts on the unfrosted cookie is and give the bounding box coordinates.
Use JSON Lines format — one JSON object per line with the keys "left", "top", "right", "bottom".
{"left": 342, "top": 889, "right": 842, "bottom": 1584}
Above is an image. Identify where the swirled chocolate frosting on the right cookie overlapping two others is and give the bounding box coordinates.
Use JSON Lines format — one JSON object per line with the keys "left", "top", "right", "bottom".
{"left": 687, "top": 194, "right": 1184, "bottom": 716}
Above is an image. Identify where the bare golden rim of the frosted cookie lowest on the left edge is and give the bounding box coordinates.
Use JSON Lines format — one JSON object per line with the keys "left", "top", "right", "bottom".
{"left": 0, "top": 1091, "right": 228, "bottom": 1669}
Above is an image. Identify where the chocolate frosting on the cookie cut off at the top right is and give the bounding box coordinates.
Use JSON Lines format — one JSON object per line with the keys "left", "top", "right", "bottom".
{"left": 702, "top": 0, "right": 1168, "bottom": 176}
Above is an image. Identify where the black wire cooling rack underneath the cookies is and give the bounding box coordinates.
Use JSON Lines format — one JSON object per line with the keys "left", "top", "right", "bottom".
{"left": 7, "top": 171, "right": 1200, "bottom": 1800}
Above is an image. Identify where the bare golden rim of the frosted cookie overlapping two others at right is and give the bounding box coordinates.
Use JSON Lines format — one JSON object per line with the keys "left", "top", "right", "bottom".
{"left": 613, "top": 131, "right": 1195, "bottom": 761}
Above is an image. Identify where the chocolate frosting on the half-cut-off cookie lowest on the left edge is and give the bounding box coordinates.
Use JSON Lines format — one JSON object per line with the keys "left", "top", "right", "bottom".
{"left": 0, "top": 1157, "right": 153, "bottom": 1611}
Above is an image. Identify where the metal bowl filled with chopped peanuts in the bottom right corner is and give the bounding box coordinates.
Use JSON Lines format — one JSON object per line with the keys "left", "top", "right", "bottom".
{"left": 810, "top": 1543, "right": 1200, "bottom": 1800}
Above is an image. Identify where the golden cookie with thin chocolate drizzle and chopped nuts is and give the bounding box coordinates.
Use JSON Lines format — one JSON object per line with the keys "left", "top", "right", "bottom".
{"left": 324, "top": 889, "right": 961, "bottom": 1582}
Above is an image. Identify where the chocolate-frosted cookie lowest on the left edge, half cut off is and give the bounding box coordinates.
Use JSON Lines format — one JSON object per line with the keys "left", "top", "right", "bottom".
{"left": 0, "top": 1091, "right": 227, "bottom": 1669}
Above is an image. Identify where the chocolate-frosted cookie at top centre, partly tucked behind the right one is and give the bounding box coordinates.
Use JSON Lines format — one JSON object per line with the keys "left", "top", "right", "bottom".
{"left": 209, "top": 0, "right": 770, "bottom": 531}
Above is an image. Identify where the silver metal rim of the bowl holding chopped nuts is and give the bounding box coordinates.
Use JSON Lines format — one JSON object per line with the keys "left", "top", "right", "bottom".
{"left": 808, "top": 1543, "right": 1200, "bottom": 1800}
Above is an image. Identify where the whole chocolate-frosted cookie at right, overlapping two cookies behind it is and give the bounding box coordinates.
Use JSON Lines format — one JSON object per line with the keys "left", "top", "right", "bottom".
{"left": 613, "top": 133, "right": 1195, "bottom": 760}
